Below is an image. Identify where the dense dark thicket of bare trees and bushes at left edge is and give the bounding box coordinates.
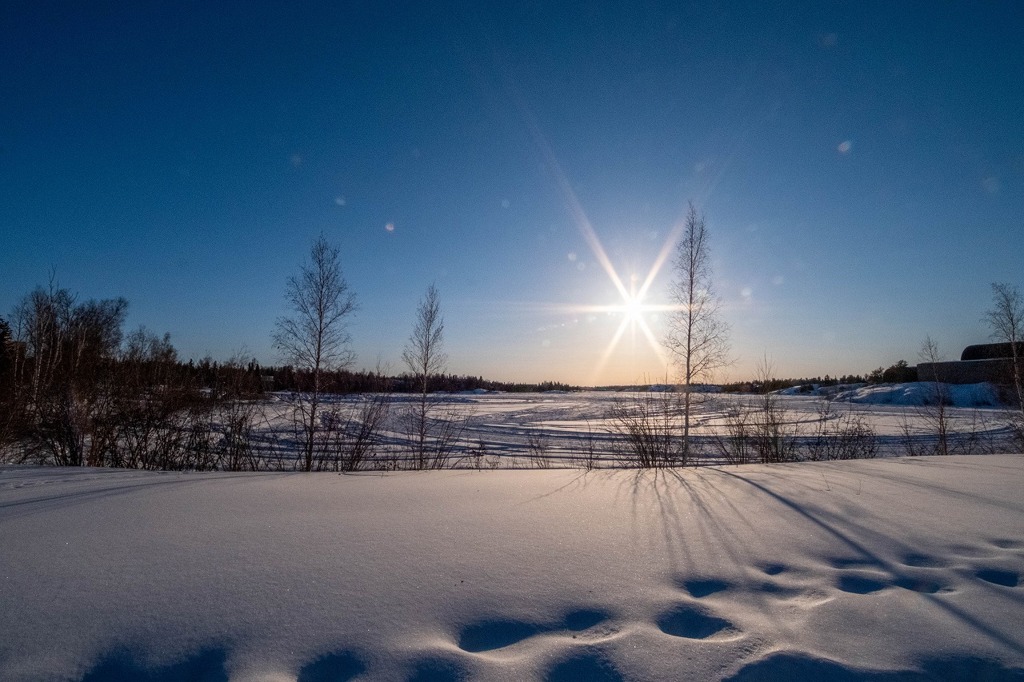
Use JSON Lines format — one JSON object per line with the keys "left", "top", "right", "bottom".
{"left": 0, "top": 283, "right": 268, "bottom": 469}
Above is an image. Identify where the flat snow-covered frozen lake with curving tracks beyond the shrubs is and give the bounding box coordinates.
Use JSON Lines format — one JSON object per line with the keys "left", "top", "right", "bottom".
{"left": 251, "top": 391, "right": 1017, "bottom": 468}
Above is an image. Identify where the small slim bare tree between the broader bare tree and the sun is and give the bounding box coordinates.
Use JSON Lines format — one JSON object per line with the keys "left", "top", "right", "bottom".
{"left": 401, "top": 284, "right": 447, "bottom": 469}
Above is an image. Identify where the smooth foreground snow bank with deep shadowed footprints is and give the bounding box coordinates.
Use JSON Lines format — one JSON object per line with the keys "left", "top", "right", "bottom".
{"left": 0, "top": 455, "right": 1024, "bottom": 682}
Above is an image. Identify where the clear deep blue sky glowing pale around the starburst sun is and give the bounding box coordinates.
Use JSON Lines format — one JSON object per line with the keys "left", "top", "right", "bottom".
{"left": 0, "top": 0, "right": 1024, "bottom": 384}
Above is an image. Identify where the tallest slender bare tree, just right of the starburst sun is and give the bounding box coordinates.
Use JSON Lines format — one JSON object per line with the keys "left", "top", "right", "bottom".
{"left": 665, "top": 203, "right": 729, "bottom": 464}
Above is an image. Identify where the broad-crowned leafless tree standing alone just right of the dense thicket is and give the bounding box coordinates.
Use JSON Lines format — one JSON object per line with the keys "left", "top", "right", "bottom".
{"left": 273, "top": 235, "right": 356, "bottom": 471}
